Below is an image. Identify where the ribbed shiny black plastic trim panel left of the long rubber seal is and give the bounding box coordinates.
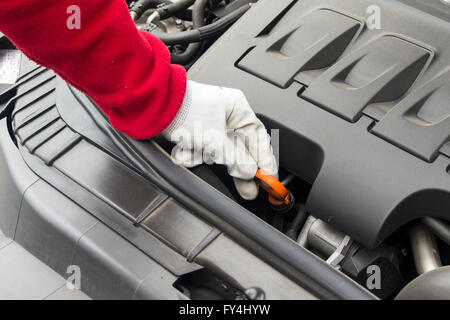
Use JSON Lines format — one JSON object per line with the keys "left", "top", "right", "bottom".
{"left": 8, "top": 68, "right": 207, "bottom": 275}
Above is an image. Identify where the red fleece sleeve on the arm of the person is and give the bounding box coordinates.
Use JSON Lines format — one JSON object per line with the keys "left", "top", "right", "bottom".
{"left": 0, "top": 0, "right": 186, "bottom": 139}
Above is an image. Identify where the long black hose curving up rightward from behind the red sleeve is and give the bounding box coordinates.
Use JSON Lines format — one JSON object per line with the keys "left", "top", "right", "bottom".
{"left": 152, "top": 5, "right": 250, "bottom": 45}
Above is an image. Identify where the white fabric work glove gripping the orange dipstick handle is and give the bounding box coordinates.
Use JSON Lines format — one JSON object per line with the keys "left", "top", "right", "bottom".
{"left": 162, "top": 81, "right": 278, "bottom": 200}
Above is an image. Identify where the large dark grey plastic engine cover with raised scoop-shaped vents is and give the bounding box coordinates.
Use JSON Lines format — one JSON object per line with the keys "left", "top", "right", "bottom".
{"left": 189, "top": 0, "right": 450, "bottom": 247}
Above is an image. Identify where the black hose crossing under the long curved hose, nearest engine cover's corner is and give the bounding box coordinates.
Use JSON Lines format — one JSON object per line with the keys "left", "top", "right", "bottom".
{"left": 171, "top": 0, "right": 209, "bottom": 65}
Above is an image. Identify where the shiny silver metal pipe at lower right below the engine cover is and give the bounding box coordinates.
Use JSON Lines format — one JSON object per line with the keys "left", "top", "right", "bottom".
{"left": 409, "top": 223, "right": 442, "bottom": 275}
